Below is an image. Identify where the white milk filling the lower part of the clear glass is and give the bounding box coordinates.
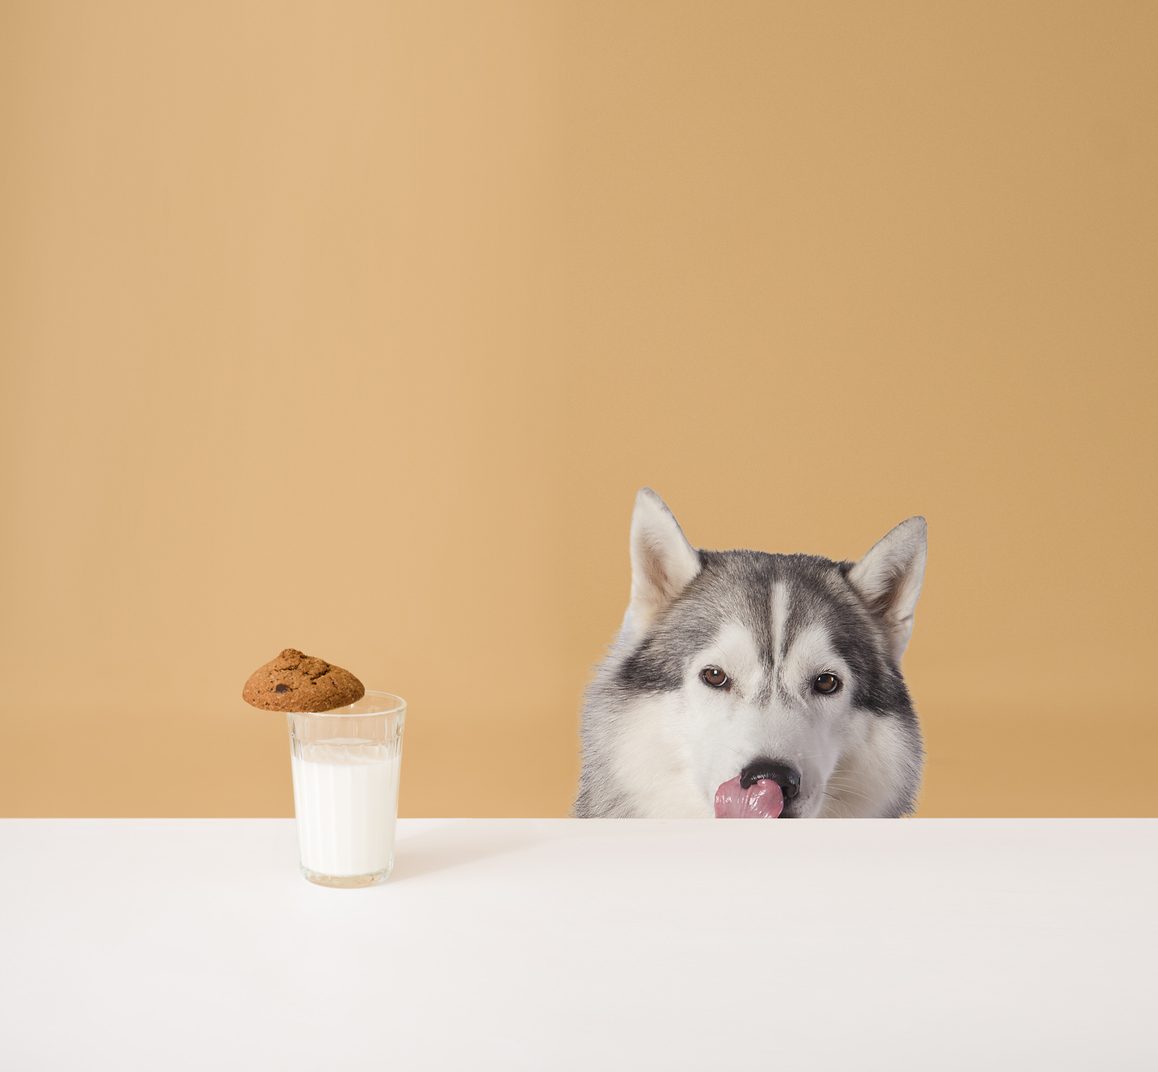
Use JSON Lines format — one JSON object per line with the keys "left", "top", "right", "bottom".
{"left": 291, "top": 737, "right": 401, "bottom": 876}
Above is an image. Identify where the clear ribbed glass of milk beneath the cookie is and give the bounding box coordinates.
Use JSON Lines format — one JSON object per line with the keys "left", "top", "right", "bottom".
{"left": 286, "top": 692, "right": 406, "bottom": 887}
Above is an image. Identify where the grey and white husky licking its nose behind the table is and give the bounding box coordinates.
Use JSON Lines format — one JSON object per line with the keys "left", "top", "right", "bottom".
{"left": 574, "top": 489, "right": 925, "bottom": 818}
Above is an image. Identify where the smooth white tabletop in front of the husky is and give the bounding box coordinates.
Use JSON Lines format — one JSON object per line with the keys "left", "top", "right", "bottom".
{"left": 0, "top": 820, "right": 1158, "bottom": 1072}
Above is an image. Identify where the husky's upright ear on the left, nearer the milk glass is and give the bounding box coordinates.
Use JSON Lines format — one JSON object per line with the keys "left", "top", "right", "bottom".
{"left": 625, "top": 487, "right": 701, "bottom": 632}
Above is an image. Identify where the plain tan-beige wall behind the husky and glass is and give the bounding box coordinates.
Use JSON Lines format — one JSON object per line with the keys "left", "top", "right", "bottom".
{"left": 0, "top": 0, "right": 1158, "bottom": 815}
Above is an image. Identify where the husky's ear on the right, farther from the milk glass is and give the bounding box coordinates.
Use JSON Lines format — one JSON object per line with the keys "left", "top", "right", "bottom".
{"left": 848, "top": 517, "right": 928, "bottom": 665}
